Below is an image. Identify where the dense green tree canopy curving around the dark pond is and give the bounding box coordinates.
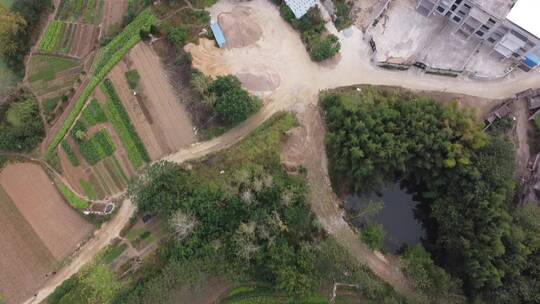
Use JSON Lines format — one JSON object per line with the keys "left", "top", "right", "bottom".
{"left": 321, "top": 88, "right": 540, "bottom": 302}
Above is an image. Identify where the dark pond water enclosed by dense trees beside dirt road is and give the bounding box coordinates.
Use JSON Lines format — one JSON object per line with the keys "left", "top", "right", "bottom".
{"left": 345, "top": 183, "right": 424, "bottom": 252}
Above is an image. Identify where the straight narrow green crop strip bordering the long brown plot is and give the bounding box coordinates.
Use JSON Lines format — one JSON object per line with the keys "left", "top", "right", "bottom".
{"left": 101, "top": 79, "right": 150, "bottom": 168}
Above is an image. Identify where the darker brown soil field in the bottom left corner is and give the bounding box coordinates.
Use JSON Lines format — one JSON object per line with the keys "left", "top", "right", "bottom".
{"left": 0, "top": 187, "right": 56, "bottom": 303}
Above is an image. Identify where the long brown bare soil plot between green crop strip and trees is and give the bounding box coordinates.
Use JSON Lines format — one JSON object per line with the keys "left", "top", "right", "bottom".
{"left": 110, "top": 43, "right": 195, "bottom": 160}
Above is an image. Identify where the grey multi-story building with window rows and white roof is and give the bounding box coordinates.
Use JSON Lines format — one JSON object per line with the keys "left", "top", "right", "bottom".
{"left": 416, "top": 0, "right": 540, "bottom": 71}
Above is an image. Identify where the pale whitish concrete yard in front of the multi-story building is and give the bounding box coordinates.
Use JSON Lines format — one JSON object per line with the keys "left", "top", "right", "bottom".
{"left": 368, "top": 0, "right": 511, "bottom": 78}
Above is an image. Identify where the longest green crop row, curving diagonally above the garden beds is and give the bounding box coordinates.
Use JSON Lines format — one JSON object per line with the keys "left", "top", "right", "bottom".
{"left": 45, "top": 9, "right": 155, "bottom": 159}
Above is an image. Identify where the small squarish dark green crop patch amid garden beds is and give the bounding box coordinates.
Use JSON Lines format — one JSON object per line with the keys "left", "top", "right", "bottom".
{"left": 76, "top": 129, "right": 116, "bottom": 166}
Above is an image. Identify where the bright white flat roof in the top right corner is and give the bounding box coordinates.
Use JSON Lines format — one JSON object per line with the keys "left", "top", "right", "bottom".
{"left": 506, "top": 0, "right": 540, "bottom": 38}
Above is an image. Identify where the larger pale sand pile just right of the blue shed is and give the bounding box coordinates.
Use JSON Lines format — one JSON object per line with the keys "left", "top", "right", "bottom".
{"left": 218, "top": 6, "right": 262, "bottom": 48}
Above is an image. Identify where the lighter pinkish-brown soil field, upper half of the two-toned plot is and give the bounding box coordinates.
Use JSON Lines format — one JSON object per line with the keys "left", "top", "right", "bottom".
{"left": 0, "top": 163, "right": 93, "bottom": 260}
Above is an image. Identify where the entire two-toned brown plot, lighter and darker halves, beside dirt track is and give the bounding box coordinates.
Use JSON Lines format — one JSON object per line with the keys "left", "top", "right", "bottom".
{"left": 0, "top": 163, "right": 93, "bottom": 303}
